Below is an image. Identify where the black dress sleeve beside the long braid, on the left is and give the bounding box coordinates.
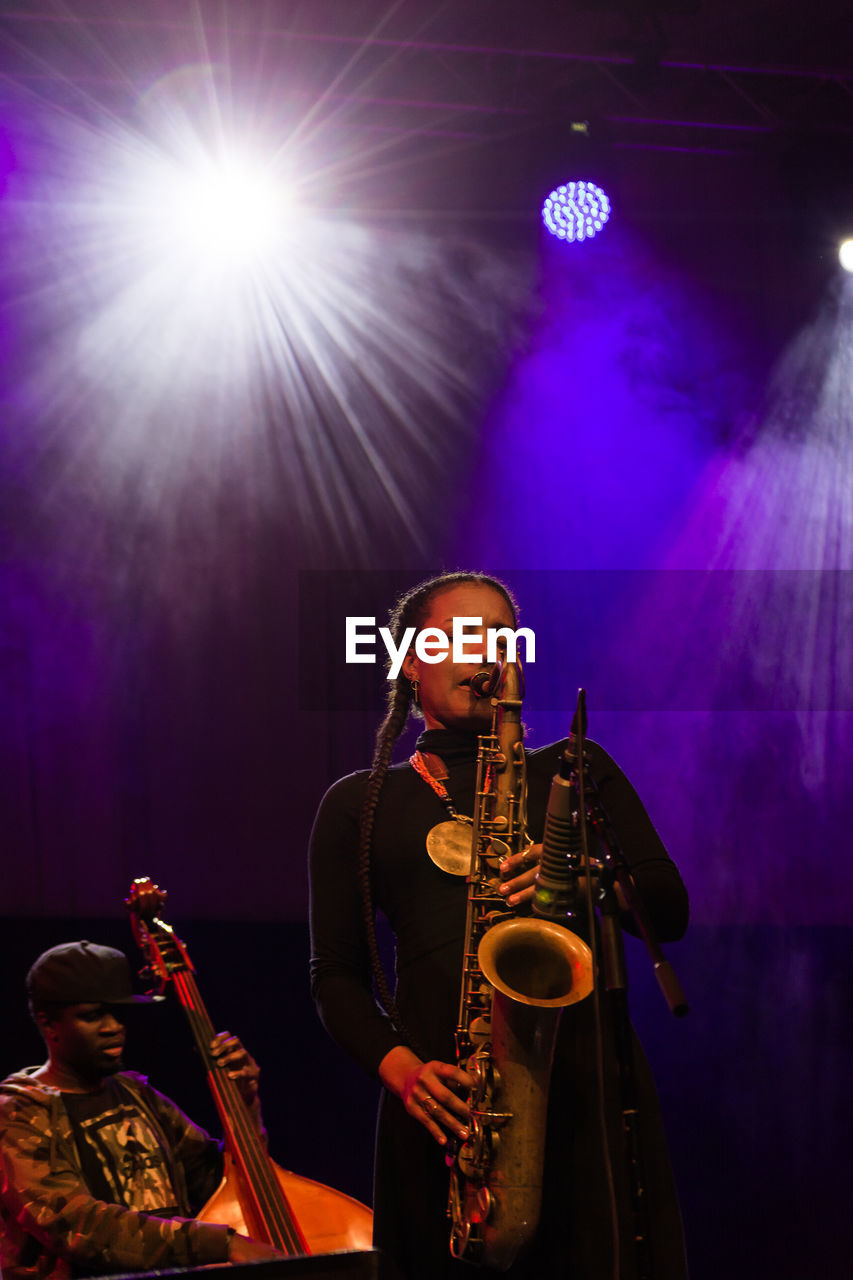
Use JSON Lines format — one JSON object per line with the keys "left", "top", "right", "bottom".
{"left": 309, "top": 774, "right": 402, "bottom": 1076}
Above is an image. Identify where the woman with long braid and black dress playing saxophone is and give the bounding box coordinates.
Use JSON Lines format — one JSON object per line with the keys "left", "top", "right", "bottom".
{"left": 311, "top": 573, "right": 686, "bottom": 1280}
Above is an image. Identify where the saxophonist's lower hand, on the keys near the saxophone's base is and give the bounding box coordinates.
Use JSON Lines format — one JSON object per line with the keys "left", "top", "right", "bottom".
{"left": 379, "top": 1044, "right": 471, "bottom": 1147}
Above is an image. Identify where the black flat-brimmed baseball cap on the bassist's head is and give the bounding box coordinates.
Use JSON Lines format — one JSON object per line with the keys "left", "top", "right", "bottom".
{"left": 27, "top": 941, "right": 163, "bottom": 1005}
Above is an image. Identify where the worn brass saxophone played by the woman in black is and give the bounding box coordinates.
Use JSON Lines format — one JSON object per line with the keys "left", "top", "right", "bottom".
{"left": 447, "top": 662, "right": 593, "bottom": 1271}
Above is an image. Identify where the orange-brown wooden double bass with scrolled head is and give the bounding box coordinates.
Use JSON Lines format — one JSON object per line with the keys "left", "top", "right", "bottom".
{"left": 124, "top": 878, "right": 373, "bottom": 1257}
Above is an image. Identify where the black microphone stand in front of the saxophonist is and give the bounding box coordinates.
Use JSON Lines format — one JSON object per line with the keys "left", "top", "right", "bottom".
{"left": 534, "top": 689, "right": 688, "bottom": 1280}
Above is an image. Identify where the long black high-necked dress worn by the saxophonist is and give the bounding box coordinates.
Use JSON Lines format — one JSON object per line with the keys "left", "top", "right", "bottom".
{"left": 310, "top": 730, "right": 688, "bottom": 1280}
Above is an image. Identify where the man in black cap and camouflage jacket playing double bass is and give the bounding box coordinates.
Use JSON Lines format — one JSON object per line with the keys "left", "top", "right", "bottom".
{"left": 0, "top": 942, "right": 279, "bottom": 1280}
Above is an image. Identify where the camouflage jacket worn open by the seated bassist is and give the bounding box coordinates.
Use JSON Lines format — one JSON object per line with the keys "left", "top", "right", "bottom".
{"left": 0, "top": 1068, "right": 229, "bottom": 1280}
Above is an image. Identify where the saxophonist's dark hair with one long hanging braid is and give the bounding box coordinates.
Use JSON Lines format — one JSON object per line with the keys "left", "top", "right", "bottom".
{"left": 359, "top": 571, "right": 519, "bottom": 1039}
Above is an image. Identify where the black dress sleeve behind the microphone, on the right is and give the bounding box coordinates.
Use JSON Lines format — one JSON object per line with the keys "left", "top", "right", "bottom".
{"left": 587, "top": 742, "right": 689, "bottom": 942}
